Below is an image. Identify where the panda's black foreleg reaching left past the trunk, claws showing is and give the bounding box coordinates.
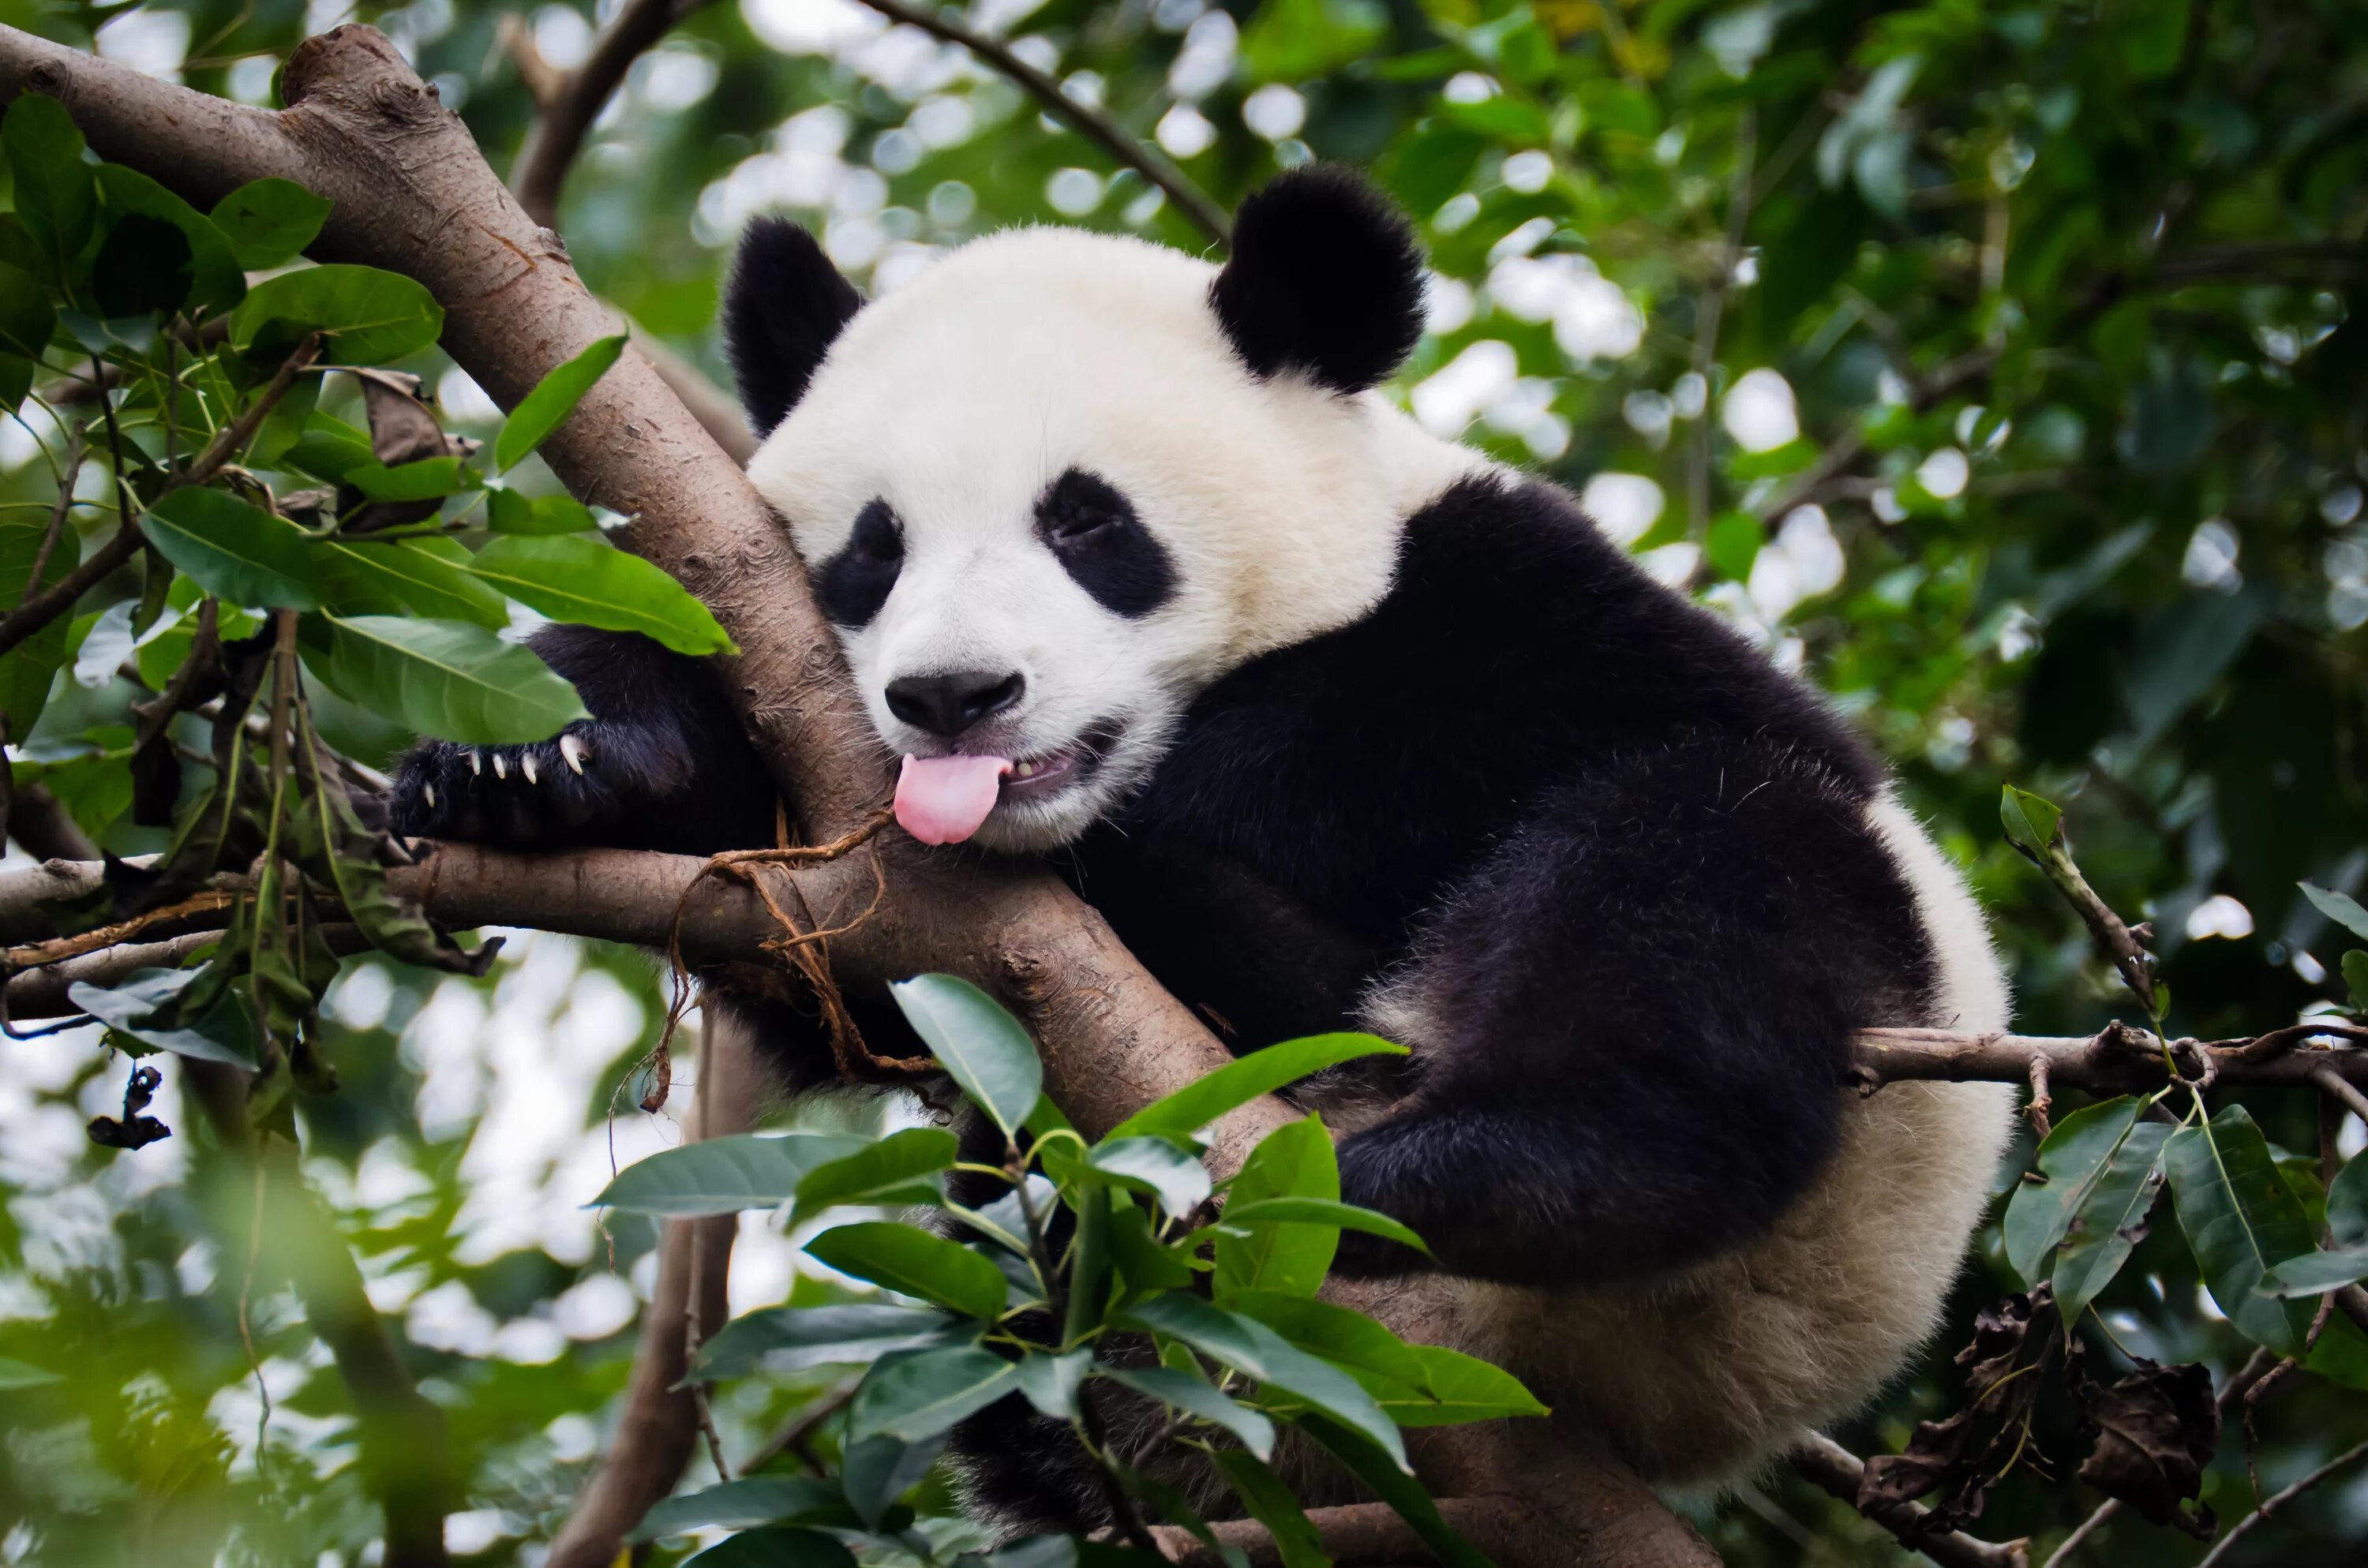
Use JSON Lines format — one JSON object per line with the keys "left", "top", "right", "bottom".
{"left": 388, "top": 625, "right": 774, "bottom": 855}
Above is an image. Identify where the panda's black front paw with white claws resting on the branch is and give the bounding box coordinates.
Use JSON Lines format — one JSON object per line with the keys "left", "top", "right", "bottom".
{"left": 388, "top": 720, "right": 689, "bottom": 848}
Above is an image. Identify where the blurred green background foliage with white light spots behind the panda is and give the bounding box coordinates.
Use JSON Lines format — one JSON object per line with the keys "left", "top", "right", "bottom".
{"left": 0, "top": 0, "right": 2368, "bottom": 1566}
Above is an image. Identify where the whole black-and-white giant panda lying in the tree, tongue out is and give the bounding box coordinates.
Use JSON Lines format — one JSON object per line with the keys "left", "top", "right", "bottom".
{"left": 393, "top": 166, "right": 2010, "bottom": 1525}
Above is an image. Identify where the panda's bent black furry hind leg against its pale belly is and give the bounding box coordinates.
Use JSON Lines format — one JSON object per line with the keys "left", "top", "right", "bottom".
{"left": 1336, "top": 739, "right": 1932, "bottom": 1284}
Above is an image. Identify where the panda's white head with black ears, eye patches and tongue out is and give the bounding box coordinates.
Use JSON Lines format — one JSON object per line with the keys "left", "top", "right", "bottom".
{"left": 725, "top": 166, "right": 1437, "bottom": 851}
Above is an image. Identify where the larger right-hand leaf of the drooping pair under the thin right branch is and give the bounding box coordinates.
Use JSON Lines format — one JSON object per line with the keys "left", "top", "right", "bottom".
{"left": 2162, "top": 1106, "right": 2311, "bottom": 1360}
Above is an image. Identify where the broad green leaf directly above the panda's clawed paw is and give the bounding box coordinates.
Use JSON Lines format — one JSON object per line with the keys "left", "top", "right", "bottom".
{"left": 305, "top": 616, "right": 592, "bottom": 746}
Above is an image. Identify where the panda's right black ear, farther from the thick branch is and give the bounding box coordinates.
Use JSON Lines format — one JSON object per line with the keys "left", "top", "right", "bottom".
{"left": 1210, "top": 163, "right": 1423, "bottom": 393}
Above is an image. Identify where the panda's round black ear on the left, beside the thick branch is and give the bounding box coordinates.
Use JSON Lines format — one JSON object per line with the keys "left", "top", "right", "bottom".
{"left": 725, "top": 218, "right": 864, "bottom": 436}
